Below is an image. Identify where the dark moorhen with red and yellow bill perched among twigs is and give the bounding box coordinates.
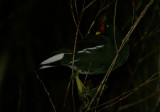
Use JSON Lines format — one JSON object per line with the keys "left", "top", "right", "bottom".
{"left": 40, "top": 23, "right": 129, "bottom": 109}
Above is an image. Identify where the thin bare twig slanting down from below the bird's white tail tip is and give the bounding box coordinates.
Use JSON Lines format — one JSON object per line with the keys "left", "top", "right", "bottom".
{"left": 34, "top": 71, "right": 56, "bottom": 112}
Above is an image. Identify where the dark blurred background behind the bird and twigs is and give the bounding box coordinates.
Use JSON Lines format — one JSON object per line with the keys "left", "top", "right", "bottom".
{"left": 0, "top": 0, "right": 160, "bottom": 112}
